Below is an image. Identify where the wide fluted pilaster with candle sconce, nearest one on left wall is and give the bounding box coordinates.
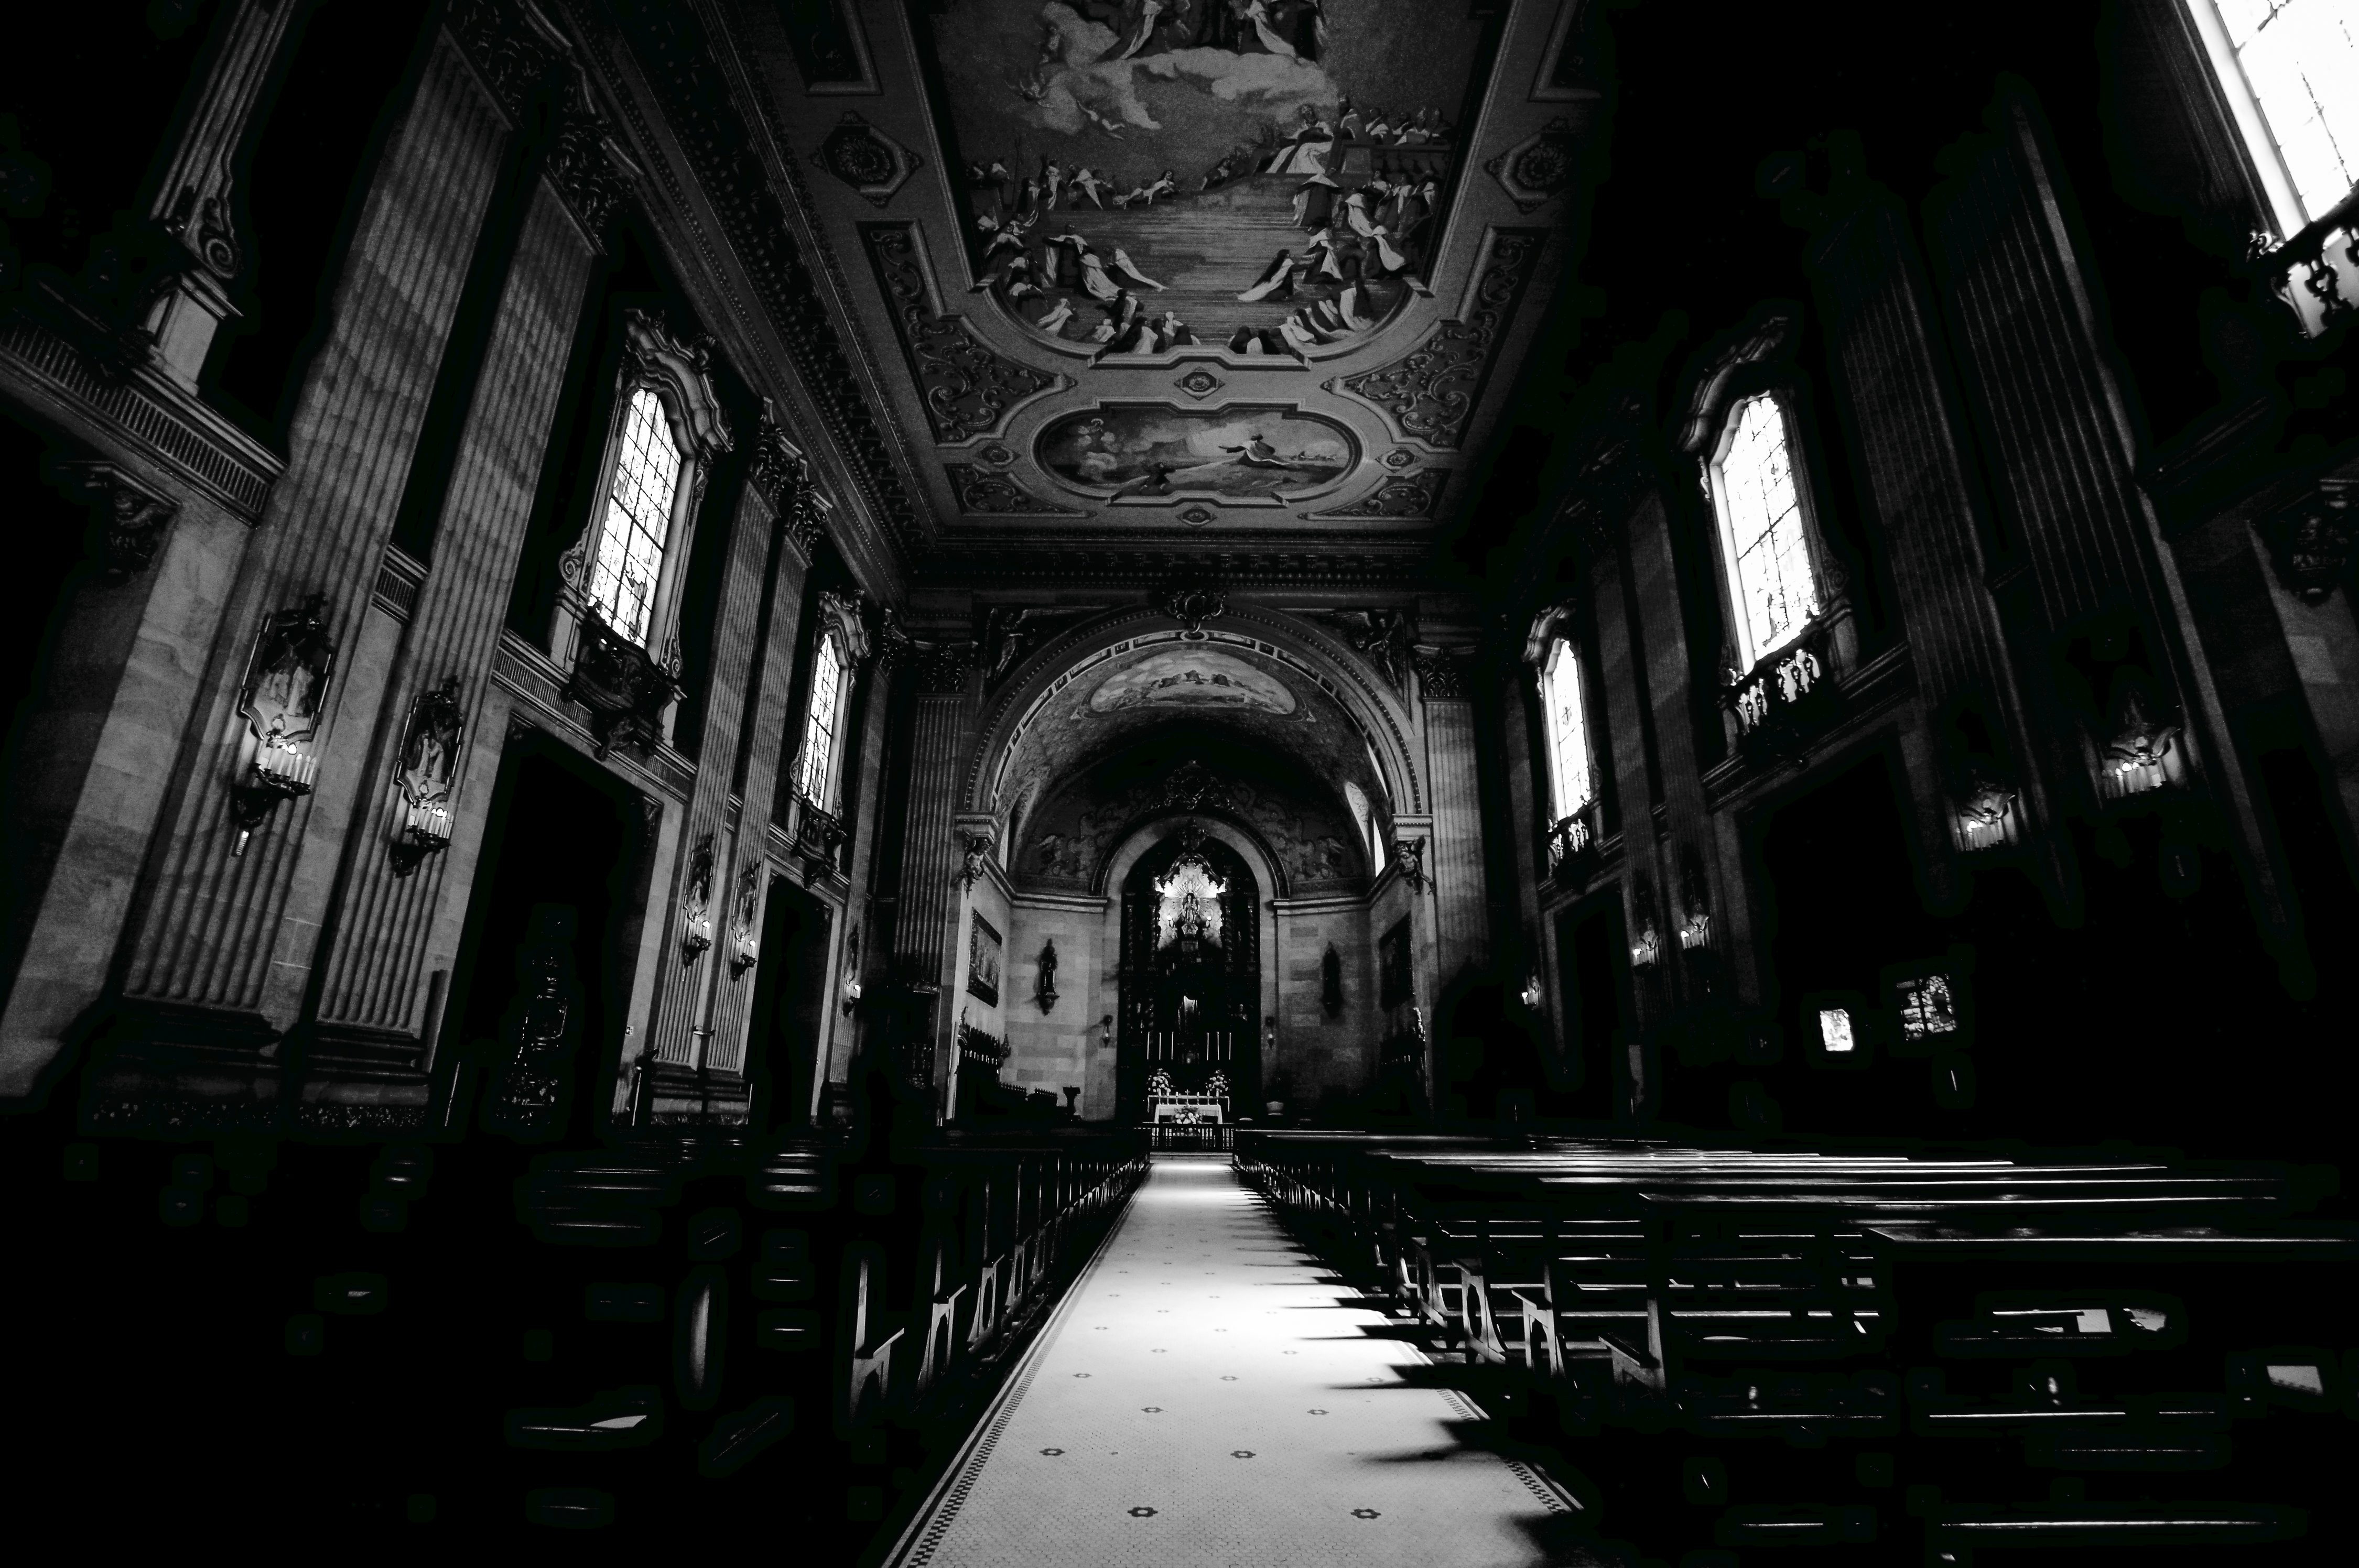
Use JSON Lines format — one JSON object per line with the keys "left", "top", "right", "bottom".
{"left": 92, "top": 35, "right": 507, "bottom": 1120}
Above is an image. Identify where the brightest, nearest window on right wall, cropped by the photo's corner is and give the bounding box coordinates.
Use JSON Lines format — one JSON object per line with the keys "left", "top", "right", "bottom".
{"left": 2187, "top": 0, "right": 2359, "bottom": 238}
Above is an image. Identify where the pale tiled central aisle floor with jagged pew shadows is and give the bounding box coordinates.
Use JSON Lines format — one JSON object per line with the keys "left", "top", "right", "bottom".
{"left": 892, "top": 1156, "right": 1569, "bottom": 1568}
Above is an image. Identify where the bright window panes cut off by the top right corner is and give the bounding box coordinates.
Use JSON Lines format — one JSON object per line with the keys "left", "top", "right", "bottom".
{"left": 2194, "top": 0, "right": 2359, "bottom": 222}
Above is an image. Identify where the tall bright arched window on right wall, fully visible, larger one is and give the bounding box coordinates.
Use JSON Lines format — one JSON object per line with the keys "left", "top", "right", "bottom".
{"left": 1713, "top": 391, "right": 1819, "bottom": 670}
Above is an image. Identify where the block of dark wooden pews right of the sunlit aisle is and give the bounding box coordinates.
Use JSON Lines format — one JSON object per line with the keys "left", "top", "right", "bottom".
{"left": 1236, "top": 1127, "right": 2359, "bottom": 1568}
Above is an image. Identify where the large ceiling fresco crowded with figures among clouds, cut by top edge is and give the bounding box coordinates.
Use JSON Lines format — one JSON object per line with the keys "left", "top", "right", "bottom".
{"left": 927, "top": 0, "right": 1484, "bottom": 358}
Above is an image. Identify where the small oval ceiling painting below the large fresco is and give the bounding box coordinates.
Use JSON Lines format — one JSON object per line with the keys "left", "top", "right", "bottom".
{"left": 1036, "top": 408, "right": 1354, "bottom": 497}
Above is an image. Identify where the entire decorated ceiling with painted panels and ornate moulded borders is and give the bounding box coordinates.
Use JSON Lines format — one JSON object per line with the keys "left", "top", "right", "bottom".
{"left": 729, "top": 0, "right": 1602, "bottom": 585}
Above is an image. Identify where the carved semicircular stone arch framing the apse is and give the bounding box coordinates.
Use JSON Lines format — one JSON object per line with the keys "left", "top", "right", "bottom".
{"left": 965, "top": 606, "right": 1427, "bottom": 842}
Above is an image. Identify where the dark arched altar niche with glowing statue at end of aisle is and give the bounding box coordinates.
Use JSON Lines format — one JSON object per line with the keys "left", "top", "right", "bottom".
{"left": 1116, "top": 823, "right": 1262, "bottom": 1123}
